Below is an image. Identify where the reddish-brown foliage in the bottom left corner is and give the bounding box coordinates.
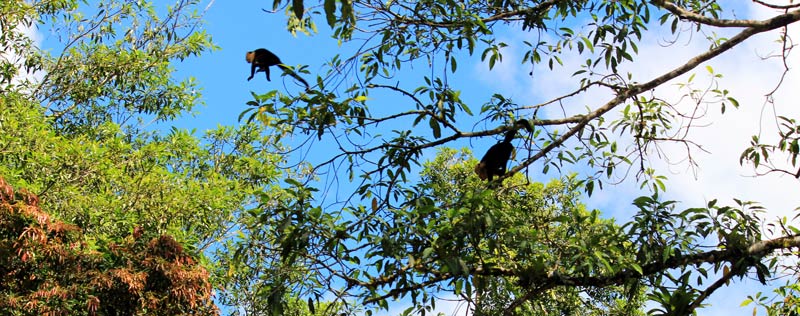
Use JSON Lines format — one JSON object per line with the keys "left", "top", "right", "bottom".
{"left": 0, "top": 178, "right": 218, "bottom": 315}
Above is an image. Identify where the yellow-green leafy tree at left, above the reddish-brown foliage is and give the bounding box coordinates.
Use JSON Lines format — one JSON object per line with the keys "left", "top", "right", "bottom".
{"left": 0, "top": 0, "right": 303, "bottom": 315}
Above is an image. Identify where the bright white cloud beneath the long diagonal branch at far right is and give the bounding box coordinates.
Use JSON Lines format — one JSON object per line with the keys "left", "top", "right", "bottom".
{"left": 648, "top": 24, "right": 800, "bottom": 225}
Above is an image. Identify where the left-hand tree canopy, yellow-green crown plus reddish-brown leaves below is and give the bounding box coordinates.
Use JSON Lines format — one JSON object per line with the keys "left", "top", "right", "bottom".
{"left": 0, "top": 1, "right": 284, "bottom": 315}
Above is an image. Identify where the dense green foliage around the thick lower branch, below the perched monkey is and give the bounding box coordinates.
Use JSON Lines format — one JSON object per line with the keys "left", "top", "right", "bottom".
{"left": 255, "top": 145, "right": 798, "bottom": 315}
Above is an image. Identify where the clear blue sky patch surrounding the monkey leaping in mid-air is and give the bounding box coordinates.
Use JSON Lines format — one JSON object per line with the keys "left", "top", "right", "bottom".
{"left": 172, "top": 1, "right": 328, "bottom": 130}
